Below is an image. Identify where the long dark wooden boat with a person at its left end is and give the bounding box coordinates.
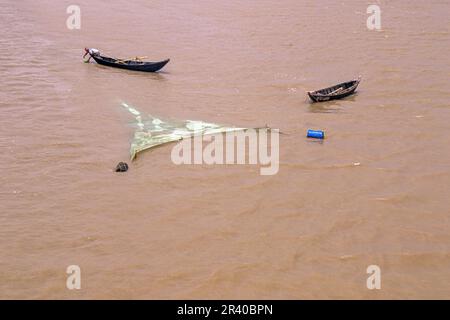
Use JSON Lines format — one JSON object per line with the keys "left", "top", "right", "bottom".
{"left": 83, "top": 48, "right": 170, "bottom": 72}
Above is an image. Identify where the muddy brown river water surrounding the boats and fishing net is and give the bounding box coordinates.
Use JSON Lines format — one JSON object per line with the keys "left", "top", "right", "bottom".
{"left": 0, "top": 0, "right": 450, "bottom": 299}
